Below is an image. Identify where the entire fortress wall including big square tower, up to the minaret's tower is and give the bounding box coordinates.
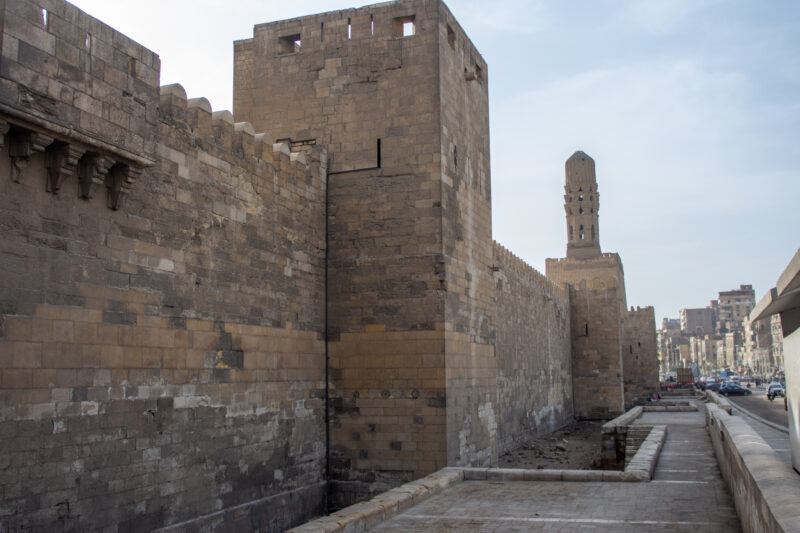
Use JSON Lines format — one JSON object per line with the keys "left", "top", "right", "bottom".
{"left": 0, "top": 0, "right": 592, "bottom": 531}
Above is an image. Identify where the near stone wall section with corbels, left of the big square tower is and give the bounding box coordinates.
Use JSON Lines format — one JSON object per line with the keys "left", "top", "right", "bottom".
{"left": 0, "top": 0, "right": 326, "bottom": 531}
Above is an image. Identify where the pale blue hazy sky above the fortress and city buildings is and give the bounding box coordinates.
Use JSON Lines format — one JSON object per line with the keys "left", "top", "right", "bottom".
{"left": 73, "top": 0, "right": 800, "bottom": 324}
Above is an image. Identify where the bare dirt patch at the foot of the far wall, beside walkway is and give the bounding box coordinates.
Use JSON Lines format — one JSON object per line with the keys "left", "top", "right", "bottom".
{"left": 497, "top": 421, "right": 603, "bottom": 470}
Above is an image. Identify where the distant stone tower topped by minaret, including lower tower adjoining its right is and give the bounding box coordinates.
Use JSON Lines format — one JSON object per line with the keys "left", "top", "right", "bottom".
{"left": 546, "top": 151, "right": 658, "bottom": 419}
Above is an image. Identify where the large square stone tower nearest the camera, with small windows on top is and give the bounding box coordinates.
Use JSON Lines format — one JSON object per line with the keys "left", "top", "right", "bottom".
{"left": 234, "top": 0, "right": 497, "bottom": 506}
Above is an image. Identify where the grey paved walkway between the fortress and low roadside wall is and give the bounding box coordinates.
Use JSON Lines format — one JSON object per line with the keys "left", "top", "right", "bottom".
{"left": 370, "top": 402, "right": 741, "bottom": 533}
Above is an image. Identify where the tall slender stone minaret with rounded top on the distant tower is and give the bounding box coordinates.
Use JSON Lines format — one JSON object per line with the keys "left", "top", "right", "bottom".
{"left": 564, "top": 151, "right": 602, "bottom": 259}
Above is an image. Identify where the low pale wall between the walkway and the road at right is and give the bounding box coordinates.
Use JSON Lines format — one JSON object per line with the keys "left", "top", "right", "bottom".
{"left": 706, "top": 403, "right": 800, "bottom": 532}
